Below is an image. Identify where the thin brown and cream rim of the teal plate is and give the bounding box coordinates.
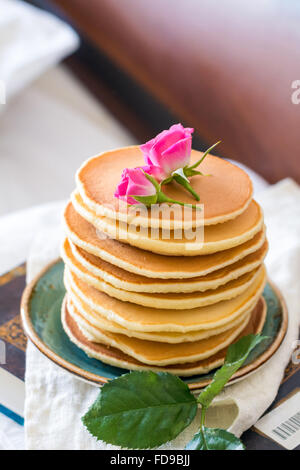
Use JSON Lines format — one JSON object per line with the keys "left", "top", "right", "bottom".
{"left": 20, "top": 257, "right": 288, "bottom": 391}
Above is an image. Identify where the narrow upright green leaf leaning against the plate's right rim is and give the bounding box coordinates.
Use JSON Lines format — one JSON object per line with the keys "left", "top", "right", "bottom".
{"left": 198, "top": 334, "right": 266, "bottom": 408}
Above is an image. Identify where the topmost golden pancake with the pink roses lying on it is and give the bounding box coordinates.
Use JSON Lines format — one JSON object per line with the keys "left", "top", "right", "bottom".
{"left": 76, "top": 146, "right": 253, "bottom": 228}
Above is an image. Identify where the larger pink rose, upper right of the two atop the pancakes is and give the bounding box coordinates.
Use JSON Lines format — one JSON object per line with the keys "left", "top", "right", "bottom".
{"left": 140, "top": 124, "right": 194, "bottom": 181}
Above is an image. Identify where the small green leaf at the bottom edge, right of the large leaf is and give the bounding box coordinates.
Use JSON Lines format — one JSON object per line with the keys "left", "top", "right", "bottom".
{"left": 186, "top": 426, "right": 245, "bottom": 450}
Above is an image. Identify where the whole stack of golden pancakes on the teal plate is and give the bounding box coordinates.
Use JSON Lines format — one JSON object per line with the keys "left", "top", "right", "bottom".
{"left": 62, "top": 147, "right": 268, "bottom": 376}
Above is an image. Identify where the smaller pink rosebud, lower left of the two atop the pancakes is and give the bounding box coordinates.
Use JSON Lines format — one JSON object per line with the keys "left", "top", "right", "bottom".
{"left": 114, "top": 167, "right": 156, "bottom": 204}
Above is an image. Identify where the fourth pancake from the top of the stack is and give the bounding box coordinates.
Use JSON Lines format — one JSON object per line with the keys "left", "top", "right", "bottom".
{"left": 61, "top": 238, "right": 268, "bottom": 293}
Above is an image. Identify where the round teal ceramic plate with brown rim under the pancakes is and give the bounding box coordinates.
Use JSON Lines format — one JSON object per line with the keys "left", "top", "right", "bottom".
{"left": 21, "top": 260, "right": 288, "bottom": 390}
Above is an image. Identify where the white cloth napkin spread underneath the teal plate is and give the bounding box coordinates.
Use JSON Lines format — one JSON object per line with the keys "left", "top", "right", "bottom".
{"left": 25, "top": 179, "right": 300, "bottom": 449}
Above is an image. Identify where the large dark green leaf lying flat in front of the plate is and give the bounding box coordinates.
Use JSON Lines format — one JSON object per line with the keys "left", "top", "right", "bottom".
{"left": 82, "top": 371, "right": 197, "bottom": 449}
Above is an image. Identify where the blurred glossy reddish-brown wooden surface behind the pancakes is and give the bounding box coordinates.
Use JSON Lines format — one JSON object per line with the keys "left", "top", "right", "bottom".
{"left": 28, "top": 0, "right": 300, "bottom": 182}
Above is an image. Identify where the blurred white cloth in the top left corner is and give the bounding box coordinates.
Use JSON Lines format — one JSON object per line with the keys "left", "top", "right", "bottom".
{"left": 0, "top": 0, "right": 79, "bottom": 100}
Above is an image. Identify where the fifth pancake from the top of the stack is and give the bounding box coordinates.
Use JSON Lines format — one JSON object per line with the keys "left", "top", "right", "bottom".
{"left": 64, "top": 250, "right": 259, "bottom": 310}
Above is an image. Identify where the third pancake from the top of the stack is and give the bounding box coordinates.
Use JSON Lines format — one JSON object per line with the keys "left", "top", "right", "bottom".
{"left": 64, "top": 199, "right": 265, "bottom": 279}
